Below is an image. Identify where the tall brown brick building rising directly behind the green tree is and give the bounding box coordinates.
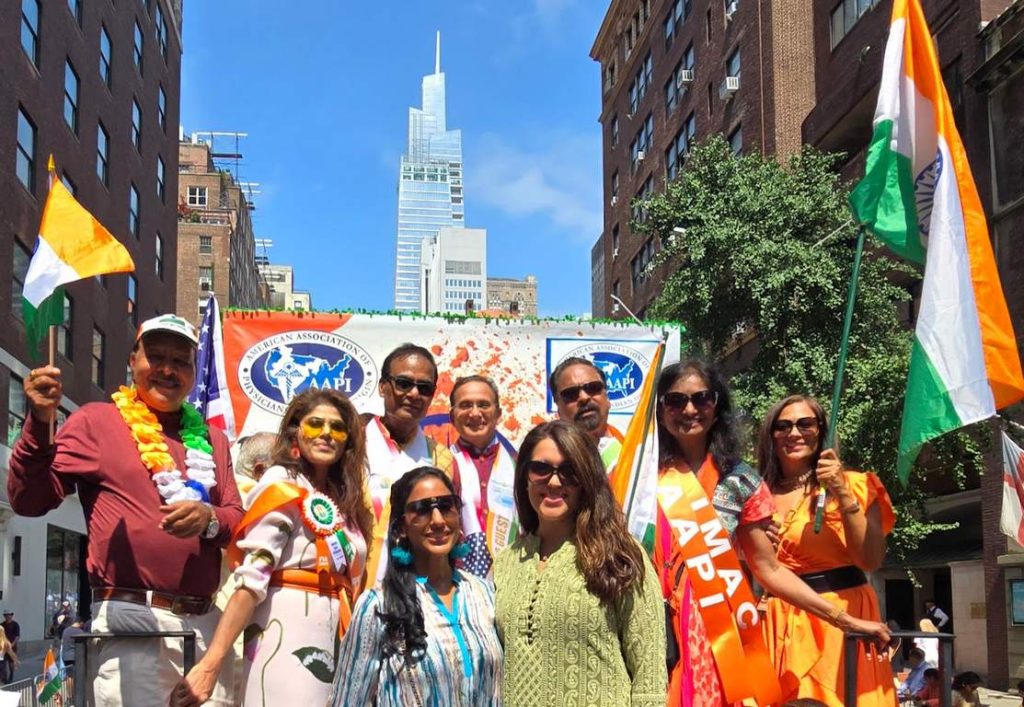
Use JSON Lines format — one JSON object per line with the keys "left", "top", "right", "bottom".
{"left": 591, "top": 0, "right": 814, "bottom": 317}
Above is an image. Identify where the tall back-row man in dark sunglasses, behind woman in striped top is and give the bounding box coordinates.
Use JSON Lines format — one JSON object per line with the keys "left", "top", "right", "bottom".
{"left": 362, "top": 343, "right": 455, "bottom": 579}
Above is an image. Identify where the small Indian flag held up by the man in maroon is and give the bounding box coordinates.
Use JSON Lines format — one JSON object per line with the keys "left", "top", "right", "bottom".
{"left": 22, "top": 157, "right": 135, "bottom": 357}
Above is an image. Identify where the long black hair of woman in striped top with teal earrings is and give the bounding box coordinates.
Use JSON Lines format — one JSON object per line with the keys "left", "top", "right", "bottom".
{"left": 377, "top": 466, "right": 456, "bottom": 665}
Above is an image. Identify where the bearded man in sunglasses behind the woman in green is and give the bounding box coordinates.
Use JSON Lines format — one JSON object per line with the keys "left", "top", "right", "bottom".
{"left": 548, "top": 357, "right": 623, "bottom": 471}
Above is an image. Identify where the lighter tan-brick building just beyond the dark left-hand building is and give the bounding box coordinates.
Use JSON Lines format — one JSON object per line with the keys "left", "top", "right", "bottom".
{"left": 176, "top": 139, "right": 269, "bottom": 323}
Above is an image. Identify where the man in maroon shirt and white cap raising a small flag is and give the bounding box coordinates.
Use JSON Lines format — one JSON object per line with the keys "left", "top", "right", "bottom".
{"left": 7, "top": 315, "right": 242, "bottom": 707}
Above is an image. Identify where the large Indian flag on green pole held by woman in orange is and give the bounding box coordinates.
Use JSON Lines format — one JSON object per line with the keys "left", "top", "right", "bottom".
{"left": 850, "top": 0, "right": 1024, "bottom": 483}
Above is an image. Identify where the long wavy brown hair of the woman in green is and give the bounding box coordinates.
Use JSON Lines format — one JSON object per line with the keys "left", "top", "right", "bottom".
{"left": 514, "top": 420, "right": 647, "bottom": 604}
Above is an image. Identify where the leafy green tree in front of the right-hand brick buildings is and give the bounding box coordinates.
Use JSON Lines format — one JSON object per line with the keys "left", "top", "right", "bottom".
{"left": 633, "top": 136, "right": 980, "bottom": 555}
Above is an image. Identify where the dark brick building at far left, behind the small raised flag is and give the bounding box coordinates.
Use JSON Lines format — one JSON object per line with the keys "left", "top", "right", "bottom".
{"left": 0, "top": 0, "right": 181, "bottom": 639}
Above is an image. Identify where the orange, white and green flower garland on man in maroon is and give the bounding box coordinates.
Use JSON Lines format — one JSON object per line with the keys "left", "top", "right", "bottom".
{"left": 111, "top": 385, "right": 217, "bottom": 503}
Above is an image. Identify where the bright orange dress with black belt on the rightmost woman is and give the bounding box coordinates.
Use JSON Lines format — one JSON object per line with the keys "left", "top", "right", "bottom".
{"left": 763, "top": 471, "right": 896, "bottom": 707}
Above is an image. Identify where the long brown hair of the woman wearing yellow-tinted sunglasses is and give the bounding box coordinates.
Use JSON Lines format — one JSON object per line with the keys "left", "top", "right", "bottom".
{"left": 270, "top": 388, "right": 374, "bottom": 542}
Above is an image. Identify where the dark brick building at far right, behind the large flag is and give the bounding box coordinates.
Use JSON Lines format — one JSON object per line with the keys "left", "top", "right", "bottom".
{"left": 803, "top": 0, "right": 1024, "bottom": 688}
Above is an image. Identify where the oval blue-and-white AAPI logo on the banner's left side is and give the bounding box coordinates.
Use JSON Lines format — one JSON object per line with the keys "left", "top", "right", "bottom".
{"left": 239, "top": 330, "right": 378, "bottom": 415}
